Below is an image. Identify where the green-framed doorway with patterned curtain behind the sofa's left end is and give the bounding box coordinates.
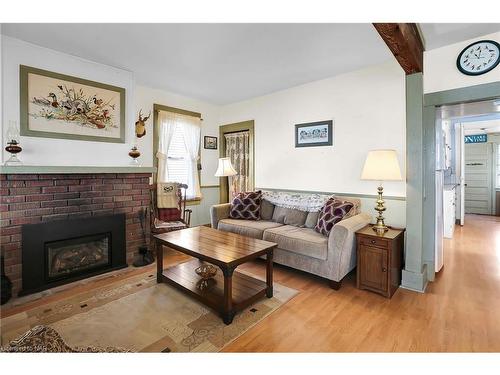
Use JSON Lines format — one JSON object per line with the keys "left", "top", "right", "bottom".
{"left": 219, "top": 120, "right": 255, "bottom": 203}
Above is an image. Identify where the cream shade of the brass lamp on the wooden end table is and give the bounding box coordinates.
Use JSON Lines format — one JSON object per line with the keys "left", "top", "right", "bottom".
{"left": 361, "top": 150, "right": 402, "bottom": 181}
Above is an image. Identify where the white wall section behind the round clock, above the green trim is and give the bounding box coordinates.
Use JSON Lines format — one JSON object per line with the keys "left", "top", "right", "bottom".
{"left": 424, "top": 32, "right": 500, "bottom": 94}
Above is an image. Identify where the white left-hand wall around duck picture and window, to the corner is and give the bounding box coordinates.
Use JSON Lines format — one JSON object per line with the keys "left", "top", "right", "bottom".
{"left": 0, "top": 35, "right": 219, "bottom": 225}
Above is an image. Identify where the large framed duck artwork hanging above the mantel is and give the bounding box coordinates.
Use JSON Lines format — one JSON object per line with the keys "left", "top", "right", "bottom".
{"left": 20, "top": 65, "right": 125, "bottom": 143}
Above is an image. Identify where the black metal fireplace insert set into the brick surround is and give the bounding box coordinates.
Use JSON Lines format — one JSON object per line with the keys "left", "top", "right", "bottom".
{"left": 20, "top": 214, "right": 127, "bottom": 295}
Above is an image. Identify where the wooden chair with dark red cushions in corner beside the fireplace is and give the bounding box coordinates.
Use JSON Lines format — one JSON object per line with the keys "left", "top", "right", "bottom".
{"left": 150, "top": 184, "right": 192, "bottom": 234}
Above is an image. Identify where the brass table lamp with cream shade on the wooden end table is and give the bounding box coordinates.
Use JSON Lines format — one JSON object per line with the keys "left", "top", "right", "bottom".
{"left": 361, "top": 150, "right": 402, "bottom": 235}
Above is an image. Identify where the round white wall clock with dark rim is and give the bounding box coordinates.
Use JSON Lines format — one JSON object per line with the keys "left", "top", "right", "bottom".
{"left": 457, "top": 40, "right": 500, "bottom": 76}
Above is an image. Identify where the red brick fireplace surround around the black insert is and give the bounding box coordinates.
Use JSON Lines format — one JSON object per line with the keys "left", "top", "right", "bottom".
{"left": 0, "top": 173, "right": 151, "bottom": 296}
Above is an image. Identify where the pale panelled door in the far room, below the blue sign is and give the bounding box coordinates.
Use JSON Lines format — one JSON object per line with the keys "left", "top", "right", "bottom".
{"left": 465, "top": 143, "right": 493, "bottom": 215}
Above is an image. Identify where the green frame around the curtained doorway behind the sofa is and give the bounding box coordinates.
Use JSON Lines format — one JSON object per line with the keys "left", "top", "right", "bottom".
{"left": 219, "top": 120, "right": 255, "bottom": 203}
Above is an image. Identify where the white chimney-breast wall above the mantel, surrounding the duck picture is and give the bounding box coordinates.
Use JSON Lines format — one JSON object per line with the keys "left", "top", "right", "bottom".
{"left": 2, "top": 35, "right": 135, "bottom": 166}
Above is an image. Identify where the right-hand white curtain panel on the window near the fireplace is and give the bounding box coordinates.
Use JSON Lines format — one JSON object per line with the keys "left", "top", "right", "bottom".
{"left": 181, "top": 115, "right": 201, "bottom": 199}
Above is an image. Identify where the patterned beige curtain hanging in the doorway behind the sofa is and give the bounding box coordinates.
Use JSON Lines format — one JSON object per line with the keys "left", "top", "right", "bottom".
{"left": 224, "top": 131, "right": 253, "bottom": 197}
